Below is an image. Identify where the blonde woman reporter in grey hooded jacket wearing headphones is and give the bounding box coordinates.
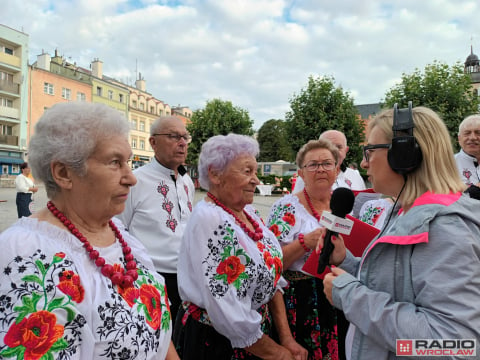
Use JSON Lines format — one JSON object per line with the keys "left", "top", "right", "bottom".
{"left": 323, "top": 103, "right": 480, "bottom": 360}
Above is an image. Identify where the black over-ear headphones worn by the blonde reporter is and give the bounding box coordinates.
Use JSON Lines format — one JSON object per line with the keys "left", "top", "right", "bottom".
{"left": 388, "top": 101, "right": 422, "bottom": 175}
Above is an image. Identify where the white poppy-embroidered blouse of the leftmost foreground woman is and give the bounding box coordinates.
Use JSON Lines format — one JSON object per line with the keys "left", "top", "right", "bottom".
{"left": 0, "top": 217, "right": 172, "bottom": 360}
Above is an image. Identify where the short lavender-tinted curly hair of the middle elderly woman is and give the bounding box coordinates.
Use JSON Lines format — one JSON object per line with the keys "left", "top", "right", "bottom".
{"left": 198, "top": 134, "right": 260, "bottom": 190}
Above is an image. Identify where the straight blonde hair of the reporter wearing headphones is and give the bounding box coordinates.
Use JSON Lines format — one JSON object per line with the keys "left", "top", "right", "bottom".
{"left": 367, "top": 107, "right": 466, "bottom": 207}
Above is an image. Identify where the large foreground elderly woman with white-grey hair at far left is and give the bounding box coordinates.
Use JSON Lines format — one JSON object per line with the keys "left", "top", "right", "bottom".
{"left": 0, "top": 103, "right": 178, "bottom": 360}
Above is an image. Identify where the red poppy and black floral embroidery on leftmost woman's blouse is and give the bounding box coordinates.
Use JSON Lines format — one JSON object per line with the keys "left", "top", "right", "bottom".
{"left": 0, "top": 250, "right": 171, "bottom": 360}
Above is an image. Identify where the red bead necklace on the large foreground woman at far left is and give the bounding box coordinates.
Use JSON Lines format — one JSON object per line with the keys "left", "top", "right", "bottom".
{"left": 47, "top": 201, "right": 138, "bottom": 289}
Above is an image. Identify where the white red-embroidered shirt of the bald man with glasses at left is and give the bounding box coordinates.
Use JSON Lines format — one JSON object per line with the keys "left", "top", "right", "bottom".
{"left": 118, "top": 158, "right": 195, "bottom": 274}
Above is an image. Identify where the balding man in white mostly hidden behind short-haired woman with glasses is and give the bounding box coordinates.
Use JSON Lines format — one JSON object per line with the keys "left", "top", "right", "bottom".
{"left": 294, "top": 130, "right": 366, "bottom": 194}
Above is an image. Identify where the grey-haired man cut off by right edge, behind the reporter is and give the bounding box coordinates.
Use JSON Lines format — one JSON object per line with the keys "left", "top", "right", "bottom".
{"left": 455, "top": 114, "right": 480, "bottom": 186}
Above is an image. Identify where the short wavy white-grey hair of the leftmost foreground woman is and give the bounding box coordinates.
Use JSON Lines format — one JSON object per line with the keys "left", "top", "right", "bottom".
{"left": 28, "top": 102, "right": 130, "bottom": 199}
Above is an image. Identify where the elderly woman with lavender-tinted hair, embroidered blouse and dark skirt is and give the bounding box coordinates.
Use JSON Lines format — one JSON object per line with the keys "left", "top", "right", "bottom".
{"left": 174, "top": 134, "right": 307, "bottom": 360}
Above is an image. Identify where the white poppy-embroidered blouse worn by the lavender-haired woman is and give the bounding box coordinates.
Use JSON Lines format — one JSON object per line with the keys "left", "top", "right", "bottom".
{"left": 178, "top": 200, "right": 287, "bottom": 348}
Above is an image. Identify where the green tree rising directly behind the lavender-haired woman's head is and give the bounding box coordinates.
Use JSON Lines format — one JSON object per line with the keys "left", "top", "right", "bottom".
{"left": 187, "top": 99, "right": 253, "bottom": 165}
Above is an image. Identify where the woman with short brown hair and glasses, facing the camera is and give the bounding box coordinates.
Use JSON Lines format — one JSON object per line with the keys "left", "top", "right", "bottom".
{"left": 267, "top": 139, "right": 339, "bottom": 359}
